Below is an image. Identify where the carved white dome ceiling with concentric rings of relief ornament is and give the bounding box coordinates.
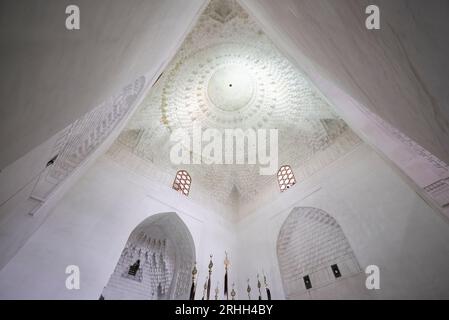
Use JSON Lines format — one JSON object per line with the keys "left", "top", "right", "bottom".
{"left": 119, "top": 0, "right": 358, "bottom": 205}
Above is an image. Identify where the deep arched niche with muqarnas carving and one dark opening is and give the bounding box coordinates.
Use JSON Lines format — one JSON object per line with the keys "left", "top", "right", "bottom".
{"left": 100, "top": 212, "right": 195, "bottom": 300}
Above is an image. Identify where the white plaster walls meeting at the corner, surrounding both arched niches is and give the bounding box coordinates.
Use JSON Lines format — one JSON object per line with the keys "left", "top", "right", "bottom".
{"left": 0, "top": 144, "right": 449, "bottom": 299}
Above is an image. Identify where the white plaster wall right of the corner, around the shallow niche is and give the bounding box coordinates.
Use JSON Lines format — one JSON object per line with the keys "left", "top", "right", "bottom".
{"left": 236, "top": 144, "right": 449, "bottom": 299}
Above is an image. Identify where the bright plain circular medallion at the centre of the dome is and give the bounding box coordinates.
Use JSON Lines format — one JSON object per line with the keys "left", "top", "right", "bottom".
{"left": 207, "top": 65, "right": 254, "bottom": 112}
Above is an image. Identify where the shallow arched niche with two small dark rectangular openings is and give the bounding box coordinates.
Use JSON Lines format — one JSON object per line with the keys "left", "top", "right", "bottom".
{"left": 277, "top": 207, "right": 361, "bottom": 299}
